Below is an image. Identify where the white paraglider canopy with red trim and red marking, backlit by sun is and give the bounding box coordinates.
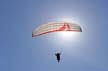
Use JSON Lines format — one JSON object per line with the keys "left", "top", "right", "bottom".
{"left": 32, "top": 22, "right": 82, "bottom": 37}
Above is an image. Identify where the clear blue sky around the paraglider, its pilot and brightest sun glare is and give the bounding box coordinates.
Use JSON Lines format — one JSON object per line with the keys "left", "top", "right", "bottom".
{"left": 0, "top": 0, "right": 108, "bottom": 71}
